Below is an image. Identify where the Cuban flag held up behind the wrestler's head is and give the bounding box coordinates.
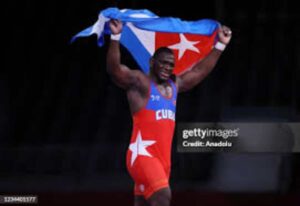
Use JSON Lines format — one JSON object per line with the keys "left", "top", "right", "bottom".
{"left": 72, "top": 8, "right": 220, "bottom": 75}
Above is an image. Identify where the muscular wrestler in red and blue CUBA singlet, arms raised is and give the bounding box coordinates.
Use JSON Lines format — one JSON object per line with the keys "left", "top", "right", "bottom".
{"left": 107, "top": 20, "right": 231, "bottom": 206}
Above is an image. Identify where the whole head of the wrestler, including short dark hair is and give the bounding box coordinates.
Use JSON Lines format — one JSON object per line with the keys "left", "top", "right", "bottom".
{"left": 150, "top": 47, "right": 175, "bottom": 81}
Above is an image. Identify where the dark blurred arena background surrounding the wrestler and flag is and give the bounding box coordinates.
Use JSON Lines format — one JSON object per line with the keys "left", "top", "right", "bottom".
{"left": 0, "top": 0, "right": 300, "bottom": 205}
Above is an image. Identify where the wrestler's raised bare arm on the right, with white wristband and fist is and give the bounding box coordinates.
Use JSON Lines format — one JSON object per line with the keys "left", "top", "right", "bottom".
{"left": 177, "top": 26, "right": 231, "bottom": 92}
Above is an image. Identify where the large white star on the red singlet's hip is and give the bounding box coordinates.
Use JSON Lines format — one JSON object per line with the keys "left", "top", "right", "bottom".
{"left": 129, "top": 131, "right": 156, "bottom": 166}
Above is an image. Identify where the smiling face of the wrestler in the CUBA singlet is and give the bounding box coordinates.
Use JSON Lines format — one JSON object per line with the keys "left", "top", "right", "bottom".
{"left": 152, "top": 53, "right": 175, "bottom": 81}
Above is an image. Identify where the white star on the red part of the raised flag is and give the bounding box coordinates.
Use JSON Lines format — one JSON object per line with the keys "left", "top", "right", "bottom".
{"left": 168, "top": 34, "right": 200, "bottom": 60}
